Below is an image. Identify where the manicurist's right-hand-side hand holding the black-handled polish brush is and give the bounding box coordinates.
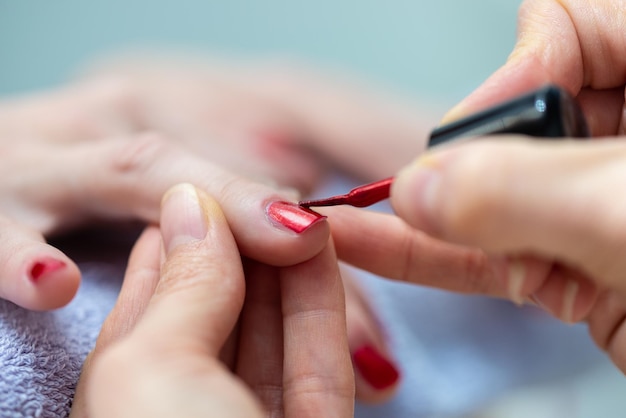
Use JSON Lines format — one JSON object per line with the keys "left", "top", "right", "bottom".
{"left": 332, "top": 0, "right": 626, "bottom": 371}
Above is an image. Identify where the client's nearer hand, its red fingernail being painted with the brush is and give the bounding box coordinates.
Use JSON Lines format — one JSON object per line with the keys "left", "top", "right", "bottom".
{"left": 0, "top": 134, "right": 329, "bottom": 309}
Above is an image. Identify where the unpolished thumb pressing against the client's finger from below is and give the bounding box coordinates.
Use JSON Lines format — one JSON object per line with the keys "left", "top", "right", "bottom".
{"left": 136, "top": 184, "right": 244, "bottom": 357}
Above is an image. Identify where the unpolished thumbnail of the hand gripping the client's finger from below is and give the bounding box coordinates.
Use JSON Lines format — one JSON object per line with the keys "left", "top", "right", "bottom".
{"left": 161, "top": 183, "right": 208, "bottom": 254}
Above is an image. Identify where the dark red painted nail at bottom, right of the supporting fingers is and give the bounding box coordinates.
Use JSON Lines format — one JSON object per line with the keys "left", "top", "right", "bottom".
{"left": 352, "top": 346, "right": 400, "bottom": 390}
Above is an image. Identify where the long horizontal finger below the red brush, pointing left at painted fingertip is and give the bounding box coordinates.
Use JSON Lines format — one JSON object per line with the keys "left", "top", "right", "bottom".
{"left": 325, "top": 207, "right": 580, "bottom": 321}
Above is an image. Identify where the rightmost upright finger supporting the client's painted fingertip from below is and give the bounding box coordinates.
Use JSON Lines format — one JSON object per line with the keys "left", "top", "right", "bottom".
{"left": 280, "top": 243, "right": 354, "bottom": 417}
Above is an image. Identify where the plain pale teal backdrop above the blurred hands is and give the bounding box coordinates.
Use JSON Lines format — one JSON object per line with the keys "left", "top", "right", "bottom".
{"left": 0, "top": 0, "right": 518, "bottom": 103}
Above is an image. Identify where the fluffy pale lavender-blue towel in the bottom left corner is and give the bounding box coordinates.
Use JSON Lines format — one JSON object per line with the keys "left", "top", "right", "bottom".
{"left": 0, "top": 263, "right": 123, "bottom": 418}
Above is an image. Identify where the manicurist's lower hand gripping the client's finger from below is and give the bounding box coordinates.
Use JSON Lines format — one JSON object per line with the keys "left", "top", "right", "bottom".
{"left": 72, "top": 185, "right": 354, "bottom": 417}
